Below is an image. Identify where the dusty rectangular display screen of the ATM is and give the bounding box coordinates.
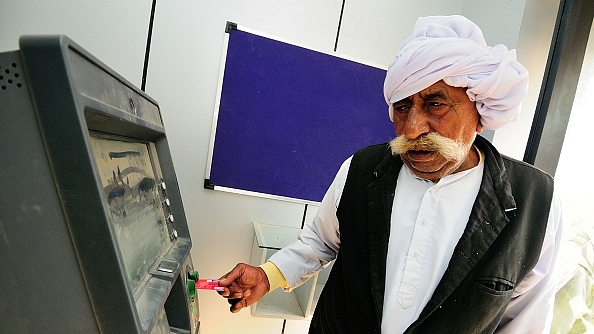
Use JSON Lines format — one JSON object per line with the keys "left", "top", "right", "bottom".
{"left": 91, "top": 134, "right": 171, "bottom": 291}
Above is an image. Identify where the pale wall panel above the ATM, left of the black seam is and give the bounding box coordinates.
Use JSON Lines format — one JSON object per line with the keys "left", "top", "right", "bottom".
{"left": 0, "top": 0, "right": 151, "bottom": 87}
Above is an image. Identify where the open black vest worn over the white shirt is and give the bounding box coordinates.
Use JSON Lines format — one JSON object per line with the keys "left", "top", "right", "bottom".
{"left": 310, "top": 136, "right": 553, "bottom": 334}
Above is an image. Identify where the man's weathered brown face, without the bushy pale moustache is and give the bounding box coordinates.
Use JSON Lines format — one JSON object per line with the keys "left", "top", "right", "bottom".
{"left": 393, "top": 81, "right": 482, "bottom": 181}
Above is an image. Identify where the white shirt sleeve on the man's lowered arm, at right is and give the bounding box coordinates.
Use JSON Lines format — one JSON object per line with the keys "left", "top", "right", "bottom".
{"left": 496, "top": 190, "right": 563, "bottom": 334}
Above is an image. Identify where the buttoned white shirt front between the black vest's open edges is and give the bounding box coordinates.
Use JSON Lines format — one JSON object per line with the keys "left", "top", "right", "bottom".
{"left": 382, "top": 159, "right": 484, "bottom": 333}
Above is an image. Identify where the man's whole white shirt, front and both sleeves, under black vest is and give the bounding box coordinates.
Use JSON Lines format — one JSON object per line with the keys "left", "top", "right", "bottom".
{"left": 270, "top": 158, "right": 561, "bottom": 333}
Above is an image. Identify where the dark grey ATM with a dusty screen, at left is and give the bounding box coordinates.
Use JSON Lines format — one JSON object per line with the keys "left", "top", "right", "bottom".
{"left": 0, "top": 35, "right": 199, "bottom": 334}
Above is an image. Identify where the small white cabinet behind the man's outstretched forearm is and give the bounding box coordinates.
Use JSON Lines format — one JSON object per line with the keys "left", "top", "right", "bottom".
{"left": 250, "top": 222, "right": 330, "bottom": 319}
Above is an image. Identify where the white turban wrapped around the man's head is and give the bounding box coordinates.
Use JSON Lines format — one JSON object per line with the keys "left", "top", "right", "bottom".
{"left": 384, "top": 15, "right": 528, "bottom": 130}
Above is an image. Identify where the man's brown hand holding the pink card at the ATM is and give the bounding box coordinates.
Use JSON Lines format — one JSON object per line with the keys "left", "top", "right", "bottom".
{"left": 219, "top": 263, "right": 270, "bottom": 313}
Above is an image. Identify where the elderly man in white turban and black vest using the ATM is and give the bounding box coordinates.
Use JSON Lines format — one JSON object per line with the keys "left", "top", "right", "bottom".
{"left": 219, "top": 16, "right": 561, "bottom": 334}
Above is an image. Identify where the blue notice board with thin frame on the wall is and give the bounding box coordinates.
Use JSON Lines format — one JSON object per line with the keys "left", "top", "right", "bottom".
{"left": 205, "top": 24, "right": 395, "bottom": 202}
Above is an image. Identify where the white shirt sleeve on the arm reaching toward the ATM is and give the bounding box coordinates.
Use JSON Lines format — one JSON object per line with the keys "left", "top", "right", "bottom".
{"left": 269, "top": 158, "right": 351, "bottom": 291}
